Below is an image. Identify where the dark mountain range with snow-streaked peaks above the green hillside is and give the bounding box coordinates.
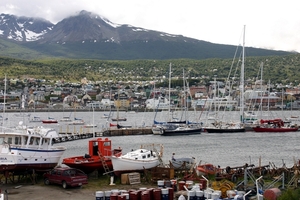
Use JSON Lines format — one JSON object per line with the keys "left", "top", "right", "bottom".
{"left": 0, "top": 11, "right": 291, "bottom": 60}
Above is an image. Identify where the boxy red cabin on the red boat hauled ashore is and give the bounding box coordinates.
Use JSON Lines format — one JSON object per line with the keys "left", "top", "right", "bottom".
{"left": 88, "top": 138, "right": 122, "bottom": 157}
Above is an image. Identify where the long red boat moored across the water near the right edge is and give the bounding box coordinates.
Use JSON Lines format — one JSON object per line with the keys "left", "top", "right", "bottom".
{"left": 253, "top": 119, "right": 299, "bottom": 132}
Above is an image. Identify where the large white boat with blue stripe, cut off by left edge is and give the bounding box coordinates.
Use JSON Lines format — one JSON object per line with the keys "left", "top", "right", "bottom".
{"left": 0, "top": 123, "right": 66, "bottom": 172}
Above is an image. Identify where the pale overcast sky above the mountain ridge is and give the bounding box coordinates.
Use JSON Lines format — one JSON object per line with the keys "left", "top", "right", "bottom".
{"left": 0, "top": 0, "right": 300, "bottom": 52}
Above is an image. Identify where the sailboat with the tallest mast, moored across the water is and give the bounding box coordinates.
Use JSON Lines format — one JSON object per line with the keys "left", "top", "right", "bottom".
{"left": 204, "top": 27, "right": 245, "bottom": 133}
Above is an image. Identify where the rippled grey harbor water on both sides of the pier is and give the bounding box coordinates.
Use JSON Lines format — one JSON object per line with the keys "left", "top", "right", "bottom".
{"left": 2, "top": 111, "right": 300, "bottom": 168}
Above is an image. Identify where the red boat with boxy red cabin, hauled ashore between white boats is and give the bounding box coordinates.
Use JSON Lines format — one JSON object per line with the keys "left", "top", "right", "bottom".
{"left": 62, "top": 138, "right": 122, "bottom": 174}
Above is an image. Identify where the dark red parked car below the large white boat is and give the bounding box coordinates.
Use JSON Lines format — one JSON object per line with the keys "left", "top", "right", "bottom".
{"left": 44, "top": 167, "right": 88, "bottom": 188}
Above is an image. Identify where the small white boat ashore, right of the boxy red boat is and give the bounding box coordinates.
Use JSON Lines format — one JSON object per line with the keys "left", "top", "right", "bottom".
{"left": 111, "top": 144, "right": 162, "bottom": 176}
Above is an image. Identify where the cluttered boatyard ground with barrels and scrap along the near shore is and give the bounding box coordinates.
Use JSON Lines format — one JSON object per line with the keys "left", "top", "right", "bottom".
{"left": 1, "top": 158, "right": 299, "bottom": 200}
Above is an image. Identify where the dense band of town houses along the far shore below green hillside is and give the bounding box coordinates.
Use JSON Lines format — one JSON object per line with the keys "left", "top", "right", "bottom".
{"left": 0, "top": 78, "right": 300, "bottom": 110}
